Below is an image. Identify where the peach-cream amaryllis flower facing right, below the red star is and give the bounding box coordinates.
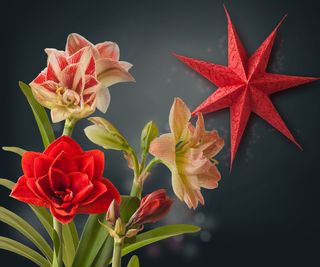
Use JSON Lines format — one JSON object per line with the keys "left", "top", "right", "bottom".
{"left": 149, "top": 98, "right": 224, "bottom": 209}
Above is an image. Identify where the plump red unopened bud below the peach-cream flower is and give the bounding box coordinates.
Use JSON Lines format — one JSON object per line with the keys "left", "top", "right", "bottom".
{"left": 127, "top": 189, "right": 173, "bottom": 228}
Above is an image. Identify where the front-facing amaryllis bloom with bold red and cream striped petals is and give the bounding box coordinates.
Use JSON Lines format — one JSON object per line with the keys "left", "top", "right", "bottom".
{"left": 30, "top": 47, "right": 102, "bottom": 122}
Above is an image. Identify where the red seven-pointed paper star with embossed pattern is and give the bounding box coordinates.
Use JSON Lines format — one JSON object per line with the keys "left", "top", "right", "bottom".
{"left": 175, "top": 8, "right": 318, "bottom": 167}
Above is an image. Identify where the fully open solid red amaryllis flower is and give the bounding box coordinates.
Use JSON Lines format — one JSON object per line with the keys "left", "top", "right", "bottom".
{"left": 11, "top": 136, "right": 120, "bottom": 224}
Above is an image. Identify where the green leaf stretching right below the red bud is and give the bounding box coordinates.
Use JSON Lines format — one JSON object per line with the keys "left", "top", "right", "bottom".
{"left": 122, "top": 224, "right": 200, "bottom": 256}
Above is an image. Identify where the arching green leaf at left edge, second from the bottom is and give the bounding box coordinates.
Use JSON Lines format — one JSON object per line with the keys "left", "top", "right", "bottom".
{"left": 0, "top": 207, "right": 53, "bottom": 262}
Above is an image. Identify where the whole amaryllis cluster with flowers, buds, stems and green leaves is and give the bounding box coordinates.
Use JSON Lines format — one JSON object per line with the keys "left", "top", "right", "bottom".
{"left": 0, "top": 34, "right": 224, "bottom": 267}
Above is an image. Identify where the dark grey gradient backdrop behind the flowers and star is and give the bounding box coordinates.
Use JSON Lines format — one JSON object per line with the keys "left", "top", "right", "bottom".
{"left": 0, "top": 0, "right": 320, "bottom": 267}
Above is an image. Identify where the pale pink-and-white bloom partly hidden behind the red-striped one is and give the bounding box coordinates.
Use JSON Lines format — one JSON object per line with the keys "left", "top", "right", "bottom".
{"left": 45, "top": 33, "right": 135, "bottom": 113}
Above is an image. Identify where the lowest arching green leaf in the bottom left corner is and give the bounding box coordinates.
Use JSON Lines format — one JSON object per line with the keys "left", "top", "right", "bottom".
{"left": 0, "top": 236, "right": 51, "bottom": 267}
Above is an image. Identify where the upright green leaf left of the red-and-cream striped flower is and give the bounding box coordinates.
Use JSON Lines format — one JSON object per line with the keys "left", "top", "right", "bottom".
{"left": 19, "top": 81, "right": 55, "bottom": 147}
